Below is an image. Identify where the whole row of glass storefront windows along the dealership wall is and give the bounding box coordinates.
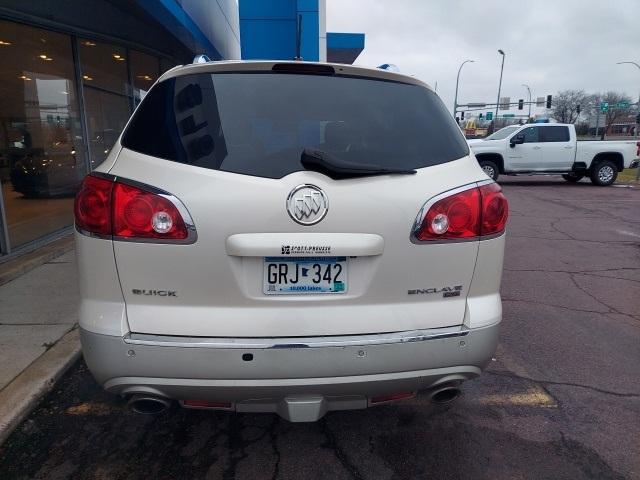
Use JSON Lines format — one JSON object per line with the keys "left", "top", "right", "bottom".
{"left": 0, "top": 20, "right": 176, "bottom": 254}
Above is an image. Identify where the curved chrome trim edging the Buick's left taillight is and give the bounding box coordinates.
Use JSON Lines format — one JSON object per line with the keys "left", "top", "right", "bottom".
{"left": 75, "top": 172, "right": 198, "bottom": 245}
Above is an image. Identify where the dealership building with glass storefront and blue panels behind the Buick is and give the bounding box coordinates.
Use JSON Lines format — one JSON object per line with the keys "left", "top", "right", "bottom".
{"left": 0, "top": 0, "right": 364, "bottom": 262}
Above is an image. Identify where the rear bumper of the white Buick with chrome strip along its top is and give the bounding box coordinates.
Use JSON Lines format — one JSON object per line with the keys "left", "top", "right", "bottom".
{"left": 81, "top": 323, "right": 499, "bottom": 420}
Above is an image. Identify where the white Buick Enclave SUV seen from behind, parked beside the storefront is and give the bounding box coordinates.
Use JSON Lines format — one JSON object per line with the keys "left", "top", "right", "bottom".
{"left": 75, "top": 62, "right": 507, "bottom": 421}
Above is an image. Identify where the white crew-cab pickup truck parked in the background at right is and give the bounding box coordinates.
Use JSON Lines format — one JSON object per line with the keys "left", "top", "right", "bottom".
{"left": 469, "top": 123, "right": 640, "bottom": 186}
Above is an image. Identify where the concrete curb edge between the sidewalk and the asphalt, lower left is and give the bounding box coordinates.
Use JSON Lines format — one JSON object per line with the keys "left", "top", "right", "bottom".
{"left": 0, "top": 328, "right": 80, "bottom": 445}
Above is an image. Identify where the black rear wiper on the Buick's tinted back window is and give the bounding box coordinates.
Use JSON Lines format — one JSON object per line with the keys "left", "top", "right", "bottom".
{"left": 300, "top": 148, "right": 416, "bottom": 180}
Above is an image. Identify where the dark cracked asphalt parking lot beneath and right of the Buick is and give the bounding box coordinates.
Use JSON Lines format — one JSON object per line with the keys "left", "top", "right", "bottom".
{"left": 0, "top": 177, "right": 640, "bottom": 480}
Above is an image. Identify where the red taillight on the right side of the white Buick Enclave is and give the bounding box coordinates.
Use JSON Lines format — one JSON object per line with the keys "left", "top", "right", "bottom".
{"left": 414, "top": 183, "right": 509, "bottom": 242}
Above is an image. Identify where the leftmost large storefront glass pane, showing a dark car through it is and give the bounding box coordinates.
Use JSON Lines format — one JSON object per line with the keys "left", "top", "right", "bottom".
{"left": 0, "top": 21, "right": 86, "bottom": 248}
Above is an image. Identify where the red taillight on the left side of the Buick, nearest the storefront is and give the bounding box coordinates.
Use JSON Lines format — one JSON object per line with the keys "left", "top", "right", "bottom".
{"left": 75, "top": 175, "right": 194, "bottom": 242}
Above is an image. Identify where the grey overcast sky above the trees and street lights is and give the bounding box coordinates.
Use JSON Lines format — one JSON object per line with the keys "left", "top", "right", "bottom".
{"left": 327, "top": 0, "right": 640, "bottom": 115}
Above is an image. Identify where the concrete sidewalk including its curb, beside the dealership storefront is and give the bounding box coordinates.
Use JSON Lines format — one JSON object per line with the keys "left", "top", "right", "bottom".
{"left": 0, "top": 242, "right": 80, "bottom": 443}
